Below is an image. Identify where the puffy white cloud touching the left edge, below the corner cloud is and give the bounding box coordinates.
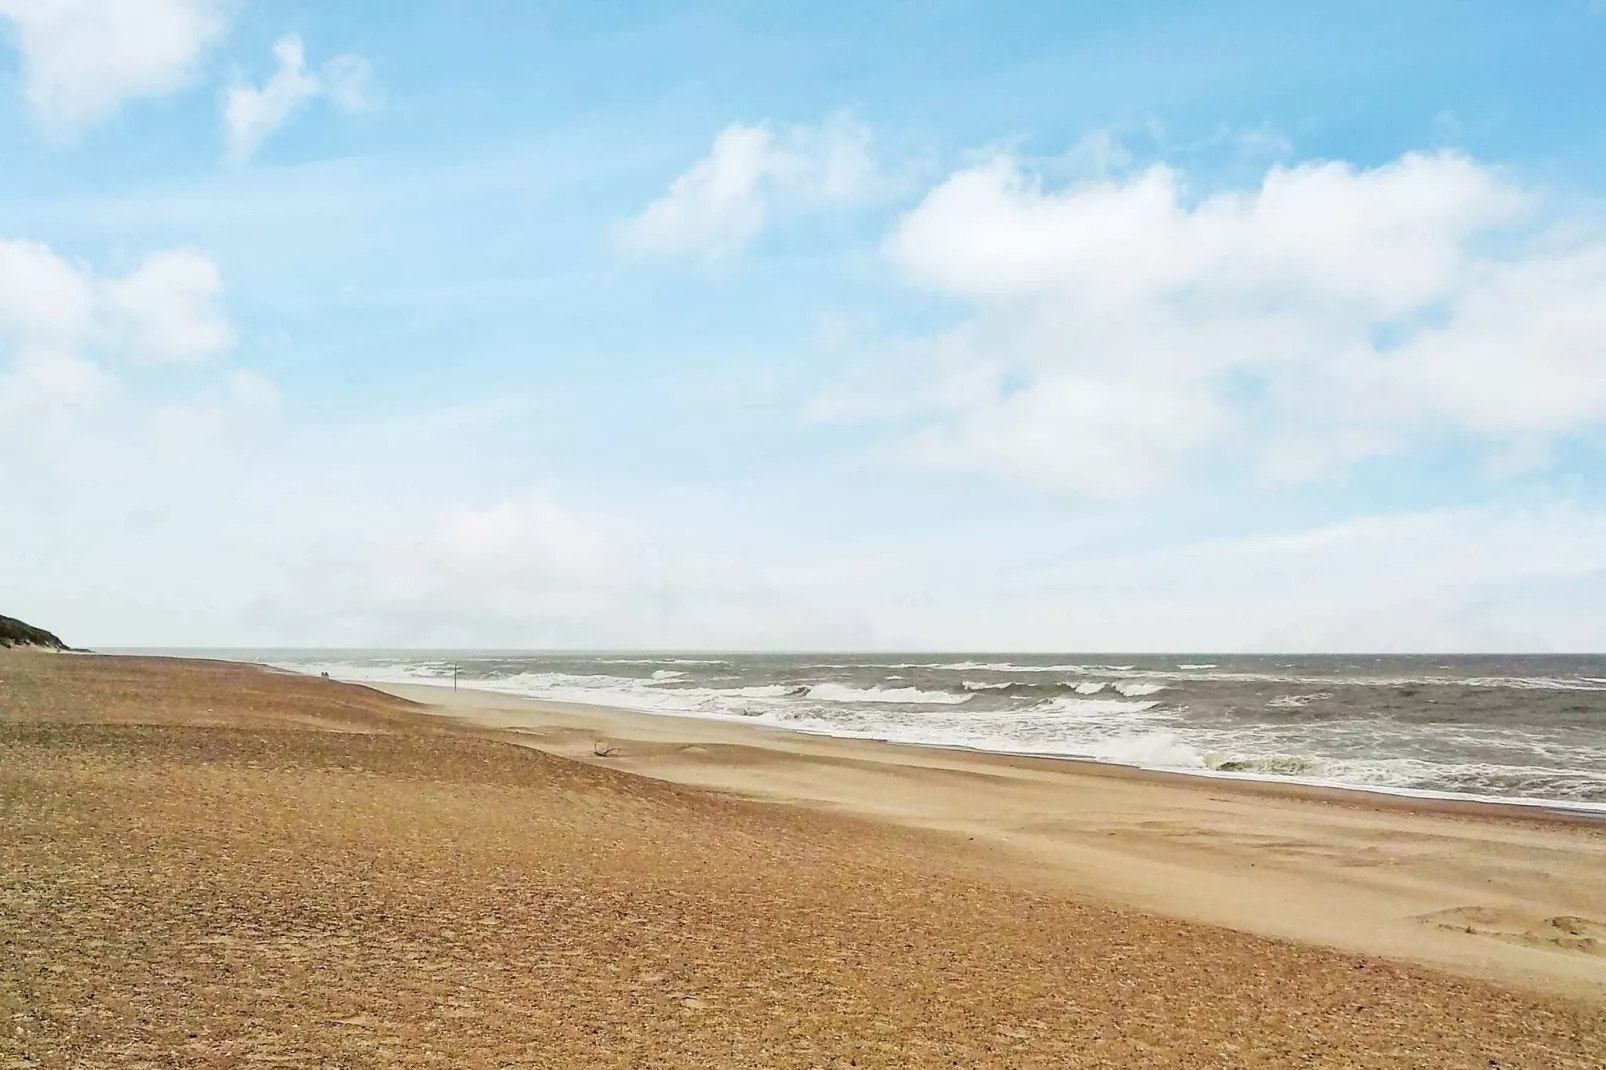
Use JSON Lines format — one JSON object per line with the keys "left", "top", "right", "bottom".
{"left": 0, "top": 241, "right": 233, "bottom": 432}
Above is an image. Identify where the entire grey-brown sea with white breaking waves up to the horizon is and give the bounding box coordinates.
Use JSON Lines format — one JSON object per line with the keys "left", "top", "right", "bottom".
{"left": 226, "top": 651, "right": 1606, "bottom": 813}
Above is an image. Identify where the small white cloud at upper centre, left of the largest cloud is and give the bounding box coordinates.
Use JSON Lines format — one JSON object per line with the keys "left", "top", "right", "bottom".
{"left": 615, "top": 114, "right": 870, "bottom": 257}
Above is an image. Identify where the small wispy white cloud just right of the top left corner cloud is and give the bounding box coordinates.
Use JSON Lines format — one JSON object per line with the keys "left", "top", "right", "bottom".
{"left": 223, "top": 35, "right": 373, "bottom": 162}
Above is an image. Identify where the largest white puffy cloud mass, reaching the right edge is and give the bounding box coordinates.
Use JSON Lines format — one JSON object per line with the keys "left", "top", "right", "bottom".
{"left": 838, "top": 153, "right": 1606, "bottom": 495}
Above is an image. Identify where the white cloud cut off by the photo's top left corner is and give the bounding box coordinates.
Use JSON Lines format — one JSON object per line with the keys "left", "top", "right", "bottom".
{"left": 0, "top": 0, "right": 226, "bottom": 132}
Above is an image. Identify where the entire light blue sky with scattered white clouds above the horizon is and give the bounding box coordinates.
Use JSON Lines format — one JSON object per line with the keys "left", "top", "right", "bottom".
{"left": 0, "top": 0, "right": 1606, "bottom": 652}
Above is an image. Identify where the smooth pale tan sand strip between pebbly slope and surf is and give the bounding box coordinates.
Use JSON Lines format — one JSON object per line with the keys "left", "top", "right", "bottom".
{"left": 364, "top": 674, "right": 1606, "bottom": 999}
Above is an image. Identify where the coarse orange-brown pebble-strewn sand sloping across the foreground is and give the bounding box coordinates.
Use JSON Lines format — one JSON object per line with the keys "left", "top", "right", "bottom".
{"left": 0, "top": 652, "right": 1606, "bottom": 1070}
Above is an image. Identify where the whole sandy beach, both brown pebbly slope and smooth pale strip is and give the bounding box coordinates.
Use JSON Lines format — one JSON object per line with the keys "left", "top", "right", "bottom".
{"left": 0, "top": 652, "right": 1606, "bottom": 1068}
